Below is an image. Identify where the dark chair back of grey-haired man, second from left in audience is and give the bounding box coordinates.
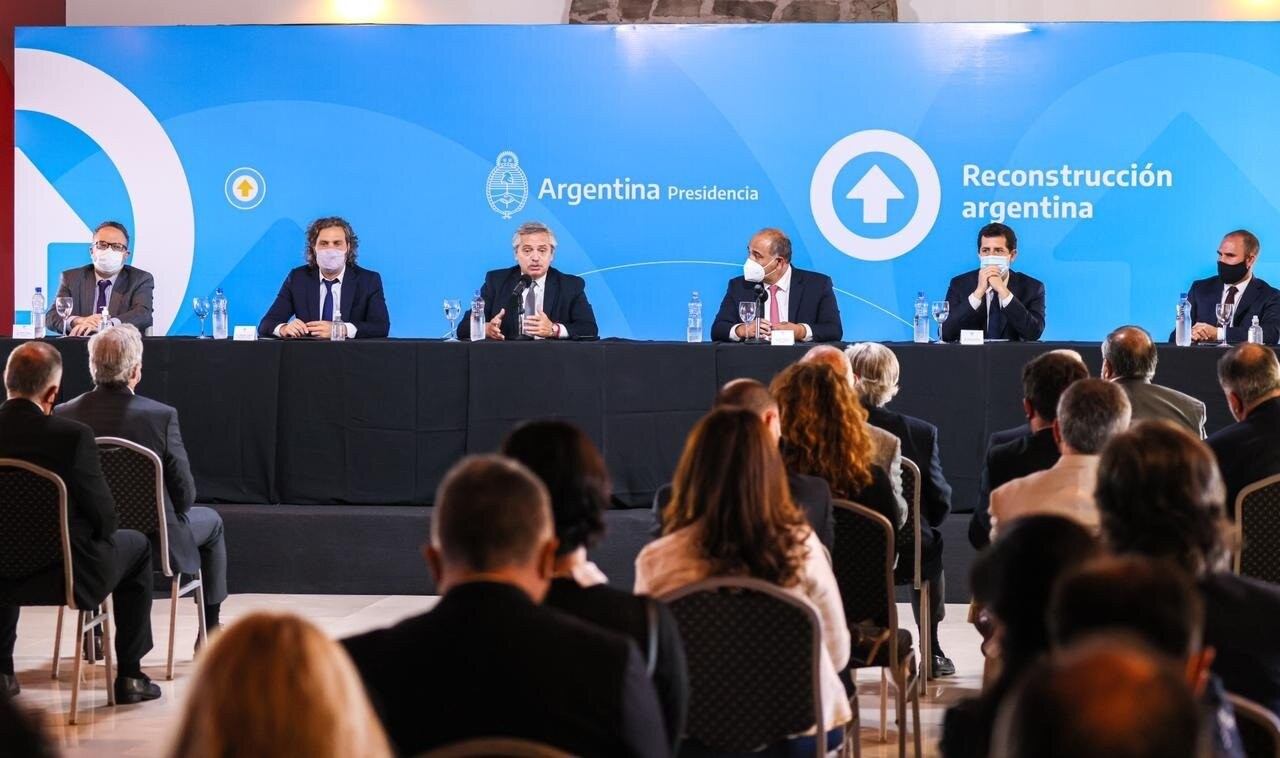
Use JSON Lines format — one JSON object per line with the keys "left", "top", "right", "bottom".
{"left": 96, "top": 437, "right": 172, "bottom": 576}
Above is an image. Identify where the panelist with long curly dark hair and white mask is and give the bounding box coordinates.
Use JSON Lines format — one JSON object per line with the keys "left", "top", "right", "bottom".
{"left": 257, "top": 216, "right": 392, "bottom": 339}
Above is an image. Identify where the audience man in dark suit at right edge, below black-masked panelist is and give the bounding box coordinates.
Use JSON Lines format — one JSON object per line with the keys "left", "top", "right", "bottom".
{"left": 1208, "top": 342, "right": 1280, "bottom": 519}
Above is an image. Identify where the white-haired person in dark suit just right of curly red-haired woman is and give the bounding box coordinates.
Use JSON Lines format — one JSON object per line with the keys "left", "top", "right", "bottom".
{"left": 845, "top": 342, "right": 956, "bottom": 676}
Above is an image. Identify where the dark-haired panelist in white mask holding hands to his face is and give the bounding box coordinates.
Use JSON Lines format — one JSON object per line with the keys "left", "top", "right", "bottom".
{"left": 942, "top": 224, "right": 1044, "bottom": 342}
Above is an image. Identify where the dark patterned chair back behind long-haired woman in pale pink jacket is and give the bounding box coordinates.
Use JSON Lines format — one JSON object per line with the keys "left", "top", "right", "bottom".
{"left": 659, "top": 576, "right": 822, "bottom": 753}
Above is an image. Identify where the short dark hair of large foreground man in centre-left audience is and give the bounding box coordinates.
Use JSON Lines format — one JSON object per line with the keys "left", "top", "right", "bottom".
{"left": 431, "top": 455, "right": 552, "bottom": 571}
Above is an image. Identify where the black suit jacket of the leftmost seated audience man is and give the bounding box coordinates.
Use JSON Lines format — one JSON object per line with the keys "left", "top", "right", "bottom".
{"left": 0, "top": 399, "right": 118, "bottom": 608}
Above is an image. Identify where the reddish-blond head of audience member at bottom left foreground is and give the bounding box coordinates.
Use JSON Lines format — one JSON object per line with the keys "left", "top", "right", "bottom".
{"left": 169, "top": 612, "right": 389, "bottom": 758}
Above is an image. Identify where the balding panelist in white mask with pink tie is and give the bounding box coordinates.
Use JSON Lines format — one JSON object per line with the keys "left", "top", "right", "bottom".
{"left": 712, "top": 229, "right": 845, "bottom": 342}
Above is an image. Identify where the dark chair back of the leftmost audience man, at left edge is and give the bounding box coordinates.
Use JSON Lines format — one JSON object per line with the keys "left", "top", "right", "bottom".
{"left": 0, "top": 458, "right": 76, "bottom": 607}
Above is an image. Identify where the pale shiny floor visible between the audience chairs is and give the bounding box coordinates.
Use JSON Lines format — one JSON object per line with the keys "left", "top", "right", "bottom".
{"left": 7, "top": 595, "right": 982, "bottom": 758}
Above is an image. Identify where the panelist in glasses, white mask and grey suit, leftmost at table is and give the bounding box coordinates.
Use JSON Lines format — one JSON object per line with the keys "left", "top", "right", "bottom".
{"left": 45, "top": 222, "right": 156, "bottom": 337}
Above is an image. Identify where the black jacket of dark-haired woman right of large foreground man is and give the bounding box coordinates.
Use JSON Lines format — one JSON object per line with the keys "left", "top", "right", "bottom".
{"left": 543, "top": 579, "right": 689, "bottom": 754}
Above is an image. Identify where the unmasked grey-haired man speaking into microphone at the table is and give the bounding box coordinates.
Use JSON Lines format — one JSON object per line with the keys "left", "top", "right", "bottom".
{"left": 458, "top": 222, "right": 599, "bottom": 339}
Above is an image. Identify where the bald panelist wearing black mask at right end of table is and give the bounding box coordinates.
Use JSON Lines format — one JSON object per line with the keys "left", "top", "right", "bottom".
{"left": 1169, "top": 229, "right": 1280, "bottom": 344}
